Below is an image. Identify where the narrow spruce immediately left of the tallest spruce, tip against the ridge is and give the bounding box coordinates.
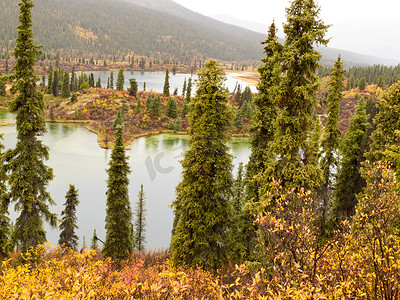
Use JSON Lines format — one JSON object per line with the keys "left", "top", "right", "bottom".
{"left": 246, "top": 23, "right": 282, "bottom": 202}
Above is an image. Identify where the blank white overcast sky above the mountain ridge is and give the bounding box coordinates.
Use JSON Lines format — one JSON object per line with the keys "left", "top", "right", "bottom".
{"left": 174, "top": 0, "right": 400, "bottom": 62}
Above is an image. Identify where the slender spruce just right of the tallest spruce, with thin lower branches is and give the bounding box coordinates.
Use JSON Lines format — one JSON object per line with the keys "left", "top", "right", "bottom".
{"left": 319, "top": 55, "right": 346, "bottom": 232}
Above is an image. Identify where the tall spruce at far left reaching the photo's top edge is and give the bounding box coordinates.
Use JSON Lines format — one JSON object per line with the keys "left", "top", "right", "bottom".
{"left": 5, "top": 0, "right": 57, "bottom": 251}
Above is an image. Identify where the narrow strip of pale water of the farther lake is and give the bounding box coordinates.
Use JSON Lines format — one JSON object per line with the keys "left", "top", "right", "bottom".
{"left": 46, "top": 70, "right": 257, "bottom": 95}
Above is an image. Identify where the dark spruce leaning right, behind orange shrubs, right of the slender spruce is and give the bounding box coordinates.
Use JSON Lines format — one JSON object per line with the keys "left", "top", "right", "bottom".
{"left": 332, "top": 98, "right": 368, "bottom": 220}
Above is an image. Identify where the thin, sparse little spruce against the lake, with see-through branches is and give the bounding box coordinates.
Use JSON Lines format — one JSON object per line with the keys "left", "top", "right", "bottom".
{"left": 133, "top": 184, "right": 146, "bottom": 251}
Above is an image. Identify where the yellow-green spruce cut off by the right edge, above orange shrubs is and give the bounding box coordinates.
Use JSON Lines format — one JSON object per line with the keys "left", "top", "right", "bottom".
{"left": 367, "top": 81, "right": 400, "bottom": 169}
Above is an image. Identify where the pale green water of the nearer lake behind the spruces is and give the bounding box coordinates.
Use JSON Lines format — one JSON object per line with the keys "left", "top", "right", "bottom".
{"left": 0, "top": 112, "right": 250, "bottom": 249}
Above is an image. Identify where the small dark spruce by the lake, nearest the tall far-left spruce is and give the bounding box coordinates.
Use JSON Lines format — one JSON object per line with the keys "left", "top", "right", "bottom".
{"left": 58, "top": 184, "right": 79, "bottom": 251}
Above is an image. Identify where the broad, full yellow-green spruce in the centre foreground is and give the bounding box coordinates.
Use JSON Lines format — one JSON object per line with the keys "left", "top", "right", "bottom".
{"left": 170, "top": 60, "right": 233, "bottom": 270}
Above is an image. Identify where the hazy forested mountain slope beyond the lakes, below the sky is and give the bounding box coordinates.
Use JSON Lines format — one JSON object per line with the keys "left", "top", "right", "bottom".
{"left": 0, "top": 0, "right": 395, "bottom": 65}
